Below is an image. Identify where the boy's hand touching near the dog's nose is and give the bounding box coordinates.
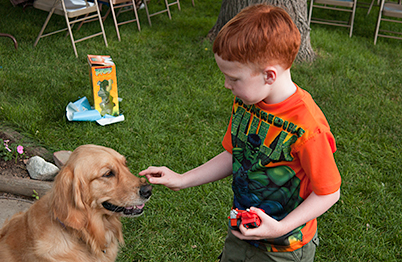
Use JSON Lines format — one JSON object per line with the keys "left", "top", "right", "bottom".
{"left": 139, "top": 166, "right": 182, "bottom": 191}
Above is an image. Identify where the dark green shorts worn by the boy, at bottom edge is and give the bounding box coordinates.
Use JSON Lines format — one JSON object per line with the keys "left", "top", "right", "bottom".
{"left": 220, "top": 230, "right": 319, "bottom": 262}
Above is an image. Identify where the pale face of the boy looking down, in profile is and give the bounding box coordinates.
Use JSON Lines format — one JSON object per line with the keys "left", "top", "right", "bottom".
{"left": 215, "top": 54, "right": 270, "bottom": 105}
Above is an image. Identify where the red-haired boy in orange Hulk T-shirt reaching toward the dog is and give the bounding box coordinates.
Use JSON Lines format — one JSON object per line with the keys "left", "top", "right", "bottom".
{"left": 140, "top": 4, "right": 341, "bottom": 261}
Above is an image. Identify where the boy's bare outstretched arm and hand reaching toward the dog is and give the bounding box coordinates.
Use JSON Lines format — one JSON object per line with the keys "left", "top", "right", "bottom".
{"left": 139, "top": 151, "right": 232, "bottom": 191}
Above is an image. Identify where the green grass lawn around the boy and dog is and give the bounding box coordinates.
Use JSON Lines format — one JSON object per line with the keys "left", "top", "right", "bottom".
{"left": 0, "top": 0, "right": 402, "bottom": 262}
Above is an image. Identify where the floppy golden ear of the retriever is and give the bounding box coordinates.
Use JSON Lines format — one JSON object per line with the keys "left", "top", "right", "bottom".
{"left": 51, "top": 166, "right": 88, "bottom": 229}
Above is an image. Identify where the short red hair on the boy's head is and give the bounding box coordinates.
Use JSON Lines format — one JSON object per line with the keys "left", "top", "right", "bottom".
{"left": 213, "top": 4, "right": 300, "bottom": 69}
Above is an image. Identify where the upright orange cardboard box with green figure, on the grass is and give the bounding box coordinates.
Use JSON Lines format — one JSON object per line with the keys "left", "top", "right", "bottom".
{"left": 88, "top": 55, "right": 119, "bottom": 116}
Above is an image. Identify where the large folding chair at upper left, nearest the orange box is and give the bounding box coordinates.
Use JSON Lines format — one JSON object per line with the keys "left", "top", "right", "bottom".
{"left": 33, "top": 0, "right": 108, "bottom": 57}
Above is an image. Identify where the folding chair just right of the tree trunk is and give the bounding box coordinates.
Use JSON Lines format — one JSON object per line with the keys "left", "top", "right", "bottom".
{"left": 308, "top": 0, "right": 357, "bottom": 37}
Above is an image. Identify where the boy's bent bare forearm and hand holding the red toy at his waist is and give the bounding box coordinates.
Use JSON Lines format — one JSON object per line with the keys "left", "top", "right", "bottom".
{"left": 232, "top": 190, "right": 340, "bottom": 240}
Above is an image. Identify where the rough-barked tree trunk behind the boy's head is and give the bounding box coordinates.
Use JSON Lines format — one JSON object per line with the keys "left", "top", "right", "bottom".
{"left": 207, "top": 0, "right": 315, "bottom": 62}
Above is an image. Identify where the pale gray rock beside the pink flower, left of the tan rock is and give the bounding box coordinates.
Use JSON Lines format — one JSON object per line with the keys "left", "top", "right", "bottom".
{"left": 26, "top": 156, "right": 60, "bottom": 180}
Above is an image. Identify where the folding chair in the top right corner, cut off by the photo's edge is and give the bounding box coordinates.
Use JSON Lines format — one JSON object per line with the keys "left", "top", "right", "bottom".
{"left": 374, "top": 0, "right": 402, "bottom": 44}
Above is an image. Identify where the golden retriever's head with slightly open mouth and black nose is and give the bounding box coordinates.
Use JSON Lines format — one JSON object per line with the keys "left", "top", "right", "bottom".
{"left": 51, "top": 145, "right": 152, "bottom": 228}
